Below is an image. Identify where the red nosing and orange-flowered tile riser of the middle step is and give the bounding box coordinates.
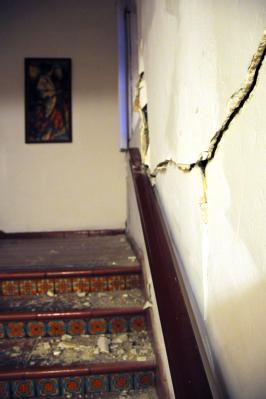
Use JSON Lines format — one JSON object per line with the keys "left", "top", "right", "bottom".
{"left": 0, "top": 307, "right": 146, "bottom": 338}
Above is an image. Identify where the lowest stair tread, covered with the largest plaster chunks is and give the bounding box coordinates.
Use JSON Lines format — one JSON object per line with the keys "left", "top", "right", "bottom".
{"left": 0, "top": 331, "right": 154, "bottom": 369}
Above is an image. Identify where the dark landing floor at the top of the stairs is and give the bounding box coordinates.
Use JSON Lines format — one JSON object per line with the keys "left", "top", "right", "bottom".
{"left": 0, "top": 234, "right": 139, "bottom": 272}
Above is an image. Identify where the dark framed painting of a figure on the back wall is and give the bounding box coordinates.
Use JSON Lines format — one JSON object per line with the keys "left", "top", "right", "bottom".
{"left": 25, "top": 58, "right": 72, "bottom": 144}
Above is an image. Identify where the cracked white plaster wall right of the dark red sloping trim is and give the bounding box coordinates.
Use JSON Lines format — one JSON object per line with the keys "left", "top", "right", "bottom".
{"left": 130, "top": 0, "right": 266, "bottom": 399}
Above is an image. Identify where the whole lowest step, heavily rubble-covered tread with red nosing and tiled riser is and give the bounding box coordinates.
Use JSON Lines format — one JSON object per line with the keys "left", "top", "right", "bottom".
{"left": 0, "top": 331, "right": 156, "bottom": 398}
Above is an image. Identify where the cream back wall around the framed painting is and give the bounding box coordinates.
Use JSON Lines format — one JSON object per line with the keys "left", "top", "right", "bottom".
{"left": 0, "top": 0, "right": 126, "bottom": 232}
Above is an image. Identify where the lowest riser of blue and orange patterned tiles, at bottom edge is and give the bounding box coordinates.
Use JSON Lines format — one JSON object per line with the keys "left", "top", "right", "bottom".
{"left": 0, "top": 371, "right": 155, "bottom": 399}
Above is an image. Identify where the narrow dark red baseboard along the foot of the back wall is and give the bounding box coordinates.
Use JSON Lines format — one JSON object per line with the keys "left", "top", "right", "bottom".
{"left": 0, "top": 229, "right": 125, "bottom": 239}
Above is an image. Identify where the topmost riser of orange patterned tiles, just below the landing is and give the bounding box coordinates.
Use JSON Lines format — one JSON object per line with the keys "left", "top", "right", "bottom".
{"left": 0, "top": 274, "right": 141, "bottom": 296}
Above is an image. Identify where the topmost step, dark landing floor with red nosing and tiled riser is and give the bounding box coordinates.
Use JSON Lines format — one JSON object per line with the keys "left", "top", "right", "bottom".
{"left": 0, "top": 235, "right": 142, "bottom": 296}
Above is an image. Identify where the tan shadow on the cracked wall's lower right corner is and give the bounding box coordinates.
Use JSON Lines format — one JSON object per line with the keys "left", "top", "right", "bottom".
{"left": 208, "top": 280, "right": 266, "bottom": 399}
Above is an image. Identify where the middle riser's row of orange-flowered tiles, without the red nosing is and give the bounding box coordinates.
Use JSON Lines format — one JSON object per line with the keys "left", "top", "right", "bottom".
{"left": 0, "top": 315, "right": 146, "bottom": 340}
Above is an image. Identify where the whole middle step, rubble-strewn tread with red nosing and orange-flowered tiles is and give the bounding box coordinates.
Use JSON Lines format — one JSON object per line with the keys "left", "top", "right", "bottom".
{"left": 0, "top": 289, "right": 146, "bottom": 338}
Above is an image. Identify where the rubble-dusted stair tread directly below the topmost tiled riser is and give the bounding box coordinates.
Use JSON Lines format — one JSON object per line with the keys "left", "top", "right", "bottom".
{"left": 0, "top": 289, "right": 145, "bottom": 314}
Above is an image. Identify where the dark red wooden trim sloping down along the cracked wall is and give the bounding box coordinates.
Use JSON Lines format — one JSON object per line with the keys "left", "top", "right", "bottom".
{"left": 129, "top": 148, "right": 213, "bottom": 399}
